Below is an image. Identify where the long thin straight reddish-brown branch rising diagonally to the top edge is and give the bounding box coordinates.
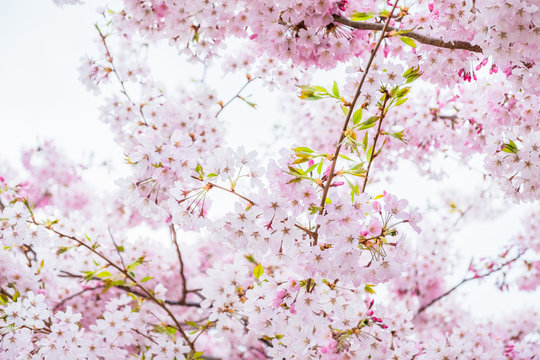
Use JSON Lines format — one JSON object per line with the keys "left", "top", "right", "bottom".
{"left": 313, "top": 0, "right": 399, "bottom": 246}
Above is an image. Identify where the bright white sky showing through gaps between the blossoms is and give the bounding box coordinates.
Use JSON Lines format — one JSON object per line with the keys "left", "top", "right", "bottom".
{"left": 0, "top": 0, "right": 539, "bottom": 315}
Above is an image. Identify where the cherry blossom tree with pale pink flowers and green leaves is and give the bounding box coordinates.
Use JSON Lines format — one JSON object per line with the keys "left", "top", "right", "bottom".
{"left": 0, "top": 0, "right": 540, "bottom": 360}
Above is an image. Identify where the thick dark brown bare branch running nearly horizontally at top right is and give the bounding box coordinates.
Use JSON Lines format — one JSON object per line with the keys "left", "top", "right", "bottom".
{"left": 334, "top": 15, "right": 483, "bottom": 53}
